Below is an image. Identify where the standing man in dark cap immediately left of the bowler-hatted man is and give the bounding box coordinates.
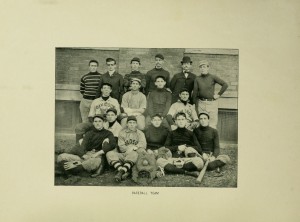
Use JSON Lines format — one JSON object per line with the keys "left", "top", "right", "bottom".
{"left": 146, "top": 54, "right": 170, "bottom": 95}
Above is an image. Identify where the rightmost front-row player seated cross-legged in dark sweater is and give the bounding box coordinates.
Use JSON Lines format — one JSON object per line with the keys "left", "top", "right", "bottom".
{"left": 194, "top": 113, "right": 230, "bottom": 170}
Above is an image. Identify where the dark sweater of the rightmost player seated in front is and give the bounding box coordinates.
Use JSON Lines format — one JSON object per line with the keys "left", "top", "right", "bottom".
{"left": 194, "top": 126, "right": 220, "bottom": 157}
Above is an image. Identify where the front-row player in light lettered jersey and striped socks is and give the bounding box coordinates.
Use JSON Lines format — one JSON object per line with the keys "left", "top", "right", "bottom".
{"left": 106, "top": 116, "right": 147, "bottom": 182}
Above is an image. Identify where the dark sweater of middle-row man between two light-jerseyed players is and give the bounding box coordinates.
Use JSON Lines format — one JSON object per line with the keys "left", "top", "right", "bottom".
{"left": 147, "top": 88, "right": 172, "bottom": 117}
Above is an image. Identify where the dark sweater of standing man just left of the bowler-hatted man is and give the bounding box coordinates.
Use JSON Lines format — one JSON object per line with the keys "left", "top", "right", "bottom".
{"left": 146, "top": 68, "right": 170, "bottom": 95}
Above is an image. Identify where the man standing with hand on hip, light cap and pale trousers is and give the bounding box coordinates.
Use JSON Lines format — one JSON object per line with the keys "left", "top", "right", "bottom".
{"left": 193, "top": 60, "right": 228, "bottom": 129}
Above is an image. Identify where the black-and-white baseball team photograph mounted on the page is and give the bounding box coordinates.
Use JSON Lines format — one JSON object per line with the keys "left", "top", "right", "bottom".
{"left": 54, "top": 47, "right": 239, "bottom": 187}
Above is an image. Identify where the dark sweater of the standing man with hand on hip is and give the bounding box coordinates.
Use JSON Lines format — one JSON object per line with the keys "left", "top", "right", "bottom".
{"left": 193, "top": 74, "right": 228, "bottom": 100}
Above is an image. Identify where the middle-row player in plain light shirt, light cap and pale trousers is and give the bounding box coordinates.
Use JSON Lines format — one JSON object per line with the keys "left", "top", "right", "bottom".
{"left": 121, "top": 78, "right": 147, "bottom": 130}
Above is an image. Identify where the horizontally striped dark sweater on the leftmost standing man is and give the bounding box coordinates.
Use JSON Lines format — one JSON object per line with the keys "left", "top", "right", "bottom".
{"left": 80, "top": 72, "right": 102, "bottom": 100}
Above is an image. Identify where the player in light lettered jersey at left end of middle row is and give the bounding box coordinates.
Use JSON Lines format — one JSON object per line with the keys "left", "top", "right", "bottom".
{"left": 75, "top": 83, "right": 120, "bottom": 142}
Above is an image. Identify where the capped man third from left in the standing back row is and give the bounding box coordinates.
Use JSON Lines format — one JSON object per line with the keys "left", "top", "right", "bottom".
{"left": 124, "top": 57, "right": 146, "bottom": 94}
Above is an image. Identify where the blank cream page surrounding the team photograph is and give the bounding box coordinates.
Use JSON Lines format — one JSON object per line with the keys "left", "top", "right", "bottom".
{"left": 0, "top": 0, "right": 300, "bottom": 222}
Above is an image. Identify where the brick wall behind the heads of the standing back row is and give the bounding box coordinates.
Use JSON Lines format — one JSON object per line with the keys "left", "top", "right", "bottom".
{"left": 55, "top": 48, "right": 239, "bottom": 97}
